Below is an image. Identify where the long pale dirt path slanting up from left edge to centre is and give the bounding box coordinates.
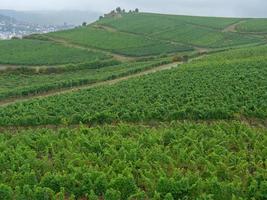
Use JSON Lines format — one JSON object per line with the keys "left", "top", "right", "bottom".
{"left": 0, "top": 62, "right": 182, "bottom": 107}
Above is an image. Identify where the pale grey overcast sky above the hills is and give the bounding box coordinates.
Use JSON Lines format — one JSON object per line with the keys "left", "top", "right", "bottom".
{"left": 0, "top": 0, "right": 267, "bottom": 17}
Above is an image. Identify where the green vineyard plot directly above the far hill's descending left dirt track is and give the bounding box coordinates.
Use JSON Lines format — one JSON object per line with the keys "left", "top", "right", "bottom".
{"left": 50, "top": 26, "right": 192, "bottom": 56}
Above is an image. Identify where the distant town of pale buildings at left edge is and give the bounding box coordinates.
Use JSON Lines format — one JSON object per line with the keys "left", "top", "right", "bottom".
{"left": 0, "top": 15, "right": 74, "bottom": 40}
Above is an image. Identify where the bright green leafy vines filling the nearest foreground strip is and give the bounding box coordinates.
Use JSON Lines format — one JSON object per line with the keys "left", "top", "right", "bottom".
{"left": 0, "top": 122, "right": 267, "bottom": 200}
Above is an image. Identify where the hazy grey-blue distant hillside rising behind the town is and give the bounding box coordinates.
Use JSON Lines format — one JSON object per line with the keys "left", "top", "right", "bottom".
{"left": 0, "top": 10, "right": 101, "bottom": 25}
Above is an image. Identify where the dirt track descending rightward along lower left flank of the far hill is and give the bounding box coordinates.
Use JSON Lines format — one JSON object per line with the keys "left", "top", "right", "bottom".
{"left": 42, "top": 35, "right": 136, "bottom": 61}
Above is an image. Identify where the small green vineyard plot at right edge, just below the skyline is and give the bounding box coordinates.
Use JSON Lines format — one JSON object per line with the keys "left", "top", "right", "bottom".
{"left": 237, "top": 19, "right": 267, "bottom": 33}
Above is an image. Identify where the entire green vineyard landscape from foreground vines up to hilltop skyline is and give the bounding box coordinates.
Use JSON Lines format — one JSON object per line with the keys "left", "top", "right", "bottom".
{"left": 0, "top": 11, "right": 267, "bottom": 200}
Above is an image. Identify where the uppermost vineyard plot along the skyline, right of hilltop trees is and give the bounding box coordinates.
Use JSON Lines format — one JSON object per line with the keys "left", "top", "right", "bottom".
{"left": 98, "top": 13, "right": 240, "bottom": 34}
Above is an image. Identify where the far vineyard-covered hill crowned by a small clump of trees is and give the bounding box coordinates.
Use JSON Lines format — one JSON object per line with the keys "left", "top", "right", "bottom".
{"left": 43, "top": 11, "right": 265, "bottom": 57}
